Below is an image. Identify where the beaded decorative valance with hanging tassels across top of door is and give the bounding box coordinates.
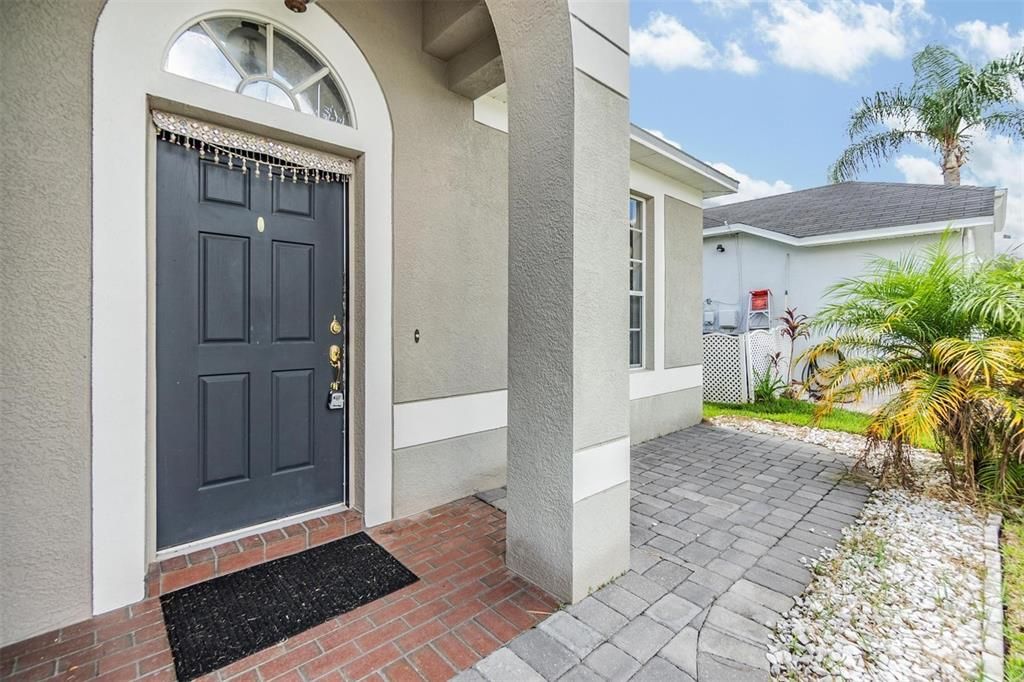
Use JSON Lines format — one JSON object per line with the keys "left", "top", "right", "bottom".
{"left": 153, "top": 110, "right": 355, "bottom": 182}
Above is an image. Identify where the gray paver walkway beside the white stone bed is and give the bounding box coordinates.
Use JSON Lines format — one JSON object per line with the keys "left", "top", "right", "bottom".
{"left": 457, "top": 425, "right": 868, "bottom": 682}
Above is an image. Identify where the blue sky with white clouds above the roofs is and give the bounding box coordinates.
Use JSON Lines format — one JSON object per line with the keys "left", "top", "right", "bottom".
{"left": 630, "top": 0, "right": 1024, "bottom": 242}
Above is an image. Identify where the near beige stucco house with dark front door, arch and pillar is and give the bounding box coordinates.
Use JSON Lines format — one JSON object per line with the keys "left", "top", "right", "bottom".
{"left": 0, "top": 0, "right": 736, "bottom": 644}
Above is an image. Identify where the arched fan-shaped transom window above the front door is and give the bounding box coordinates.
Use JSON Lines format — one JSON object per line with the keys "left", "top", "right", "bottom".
{"left": 166, "top": 16, "right": 352, "bottom": 125}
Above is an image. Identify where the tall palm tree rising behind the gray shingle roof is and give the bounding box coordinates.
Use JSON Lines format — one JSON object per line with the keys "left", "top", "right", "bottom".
{"left": 828, "top": 45, "right": 1024, "bottom": 185}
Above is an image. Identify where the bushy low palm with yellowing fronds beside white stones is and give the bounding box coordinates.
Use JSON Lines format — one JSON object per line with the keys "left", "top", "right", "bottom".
{"left": 803, "top": 233, "right": 1024, "bottom": 497}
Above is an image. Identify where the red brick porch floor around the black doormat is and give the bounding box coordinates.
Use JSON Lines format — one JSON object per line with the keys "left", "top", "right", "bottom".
{"left": 0, "top": 498, "right": 556, "bottom": 681}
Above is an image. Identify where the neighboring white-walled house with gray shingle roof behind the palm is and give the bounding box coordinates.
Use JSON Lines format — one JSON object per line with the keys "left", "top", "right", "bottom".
{"left": 703, "top": 182, "right": 1006, "bottom": 332}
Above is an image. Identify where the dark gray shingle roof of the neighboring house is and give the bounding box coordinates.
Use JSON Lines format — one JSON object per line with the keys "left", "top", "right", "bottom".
{"left": 703, "top": 182, "right": 995, "bottom": 239}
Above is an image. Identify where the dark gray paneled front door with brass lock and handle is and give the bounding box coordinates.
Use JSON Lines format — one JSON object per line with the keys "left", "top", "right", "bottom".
{"left": 157, "top": 140, "right": 346, "bottom": 548}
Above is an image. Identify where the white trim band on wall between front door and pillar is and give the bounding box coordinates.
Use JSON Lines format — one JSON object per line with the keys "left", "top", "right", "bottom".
{"left": 394, "top": 390, "right": 508, "bottom": 450}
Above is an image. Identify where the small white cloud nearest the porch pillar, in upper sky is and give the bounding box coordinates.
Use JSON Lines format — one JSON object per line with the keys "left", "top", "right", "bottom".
{"left": 630, "top": 12, "right": 758, "bottom": 75}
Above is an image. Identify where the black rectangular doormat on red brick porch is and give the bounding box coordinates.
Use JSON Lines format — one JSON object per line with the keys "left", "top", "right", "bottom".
{"left": 160, "top": 532, "right": 419, "bottom": 680}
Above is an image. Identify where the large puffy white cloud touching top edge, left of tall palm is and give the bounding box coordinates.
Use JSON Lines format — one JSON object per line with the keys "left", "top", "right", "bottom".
{"left": 756, "top": 0, "right": 929, "bottom": 81}
